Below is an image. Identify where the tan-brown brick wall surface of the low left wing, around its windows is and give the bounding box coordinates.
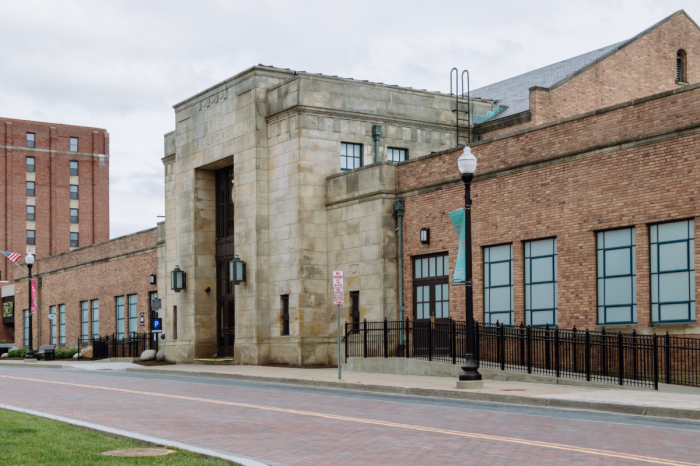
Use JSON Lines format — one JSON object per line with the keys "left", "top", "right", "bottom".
{"left": 15, "top": 228, "right": 158, "bottom": 347}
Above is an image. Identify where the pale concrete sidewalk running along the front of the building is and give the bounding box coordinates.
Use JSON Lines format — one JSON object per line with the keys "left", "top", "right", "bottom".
{"left": 0, "top": 361, "right": 700, "bottom": 420}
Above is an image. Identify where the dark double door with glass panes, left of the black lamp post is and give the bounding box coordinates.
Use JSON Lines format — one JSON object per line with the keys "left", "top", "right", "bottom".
{"left": 413, "top": 253, "right": 451, "bottom": 358}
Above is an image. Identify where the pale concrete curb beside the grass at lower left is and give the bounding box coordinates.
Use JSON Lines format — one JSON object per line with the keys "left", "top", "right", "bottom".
{"left": 0, "top": 404, "right": 268, "bottom": 466}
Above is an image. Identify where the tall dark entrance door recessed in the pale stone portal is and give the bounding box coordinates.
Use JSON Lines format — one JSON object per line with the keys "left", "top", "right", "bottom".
{"left": 216, "top": 167, "right": 236, "bottom": 357}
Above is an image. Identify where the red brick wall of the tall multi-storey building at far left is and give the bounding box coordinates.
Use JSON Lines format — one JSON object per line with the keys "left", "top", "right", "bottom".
{"left": 0, "top": 119, "right": 109, "bottom": 288}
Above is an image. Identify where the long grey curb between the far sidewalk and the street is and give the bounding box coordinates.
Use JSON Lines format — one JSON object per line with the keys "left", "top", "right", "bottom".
{"left": 126, "top": 368, "right": 700, "bottom": 421}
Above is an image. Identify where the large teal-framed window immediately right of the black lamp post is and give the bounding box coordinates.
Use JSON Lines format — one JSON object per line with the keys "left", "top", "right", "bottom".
{"left": 484, "top": 244, "right": 513, "bottom": 325}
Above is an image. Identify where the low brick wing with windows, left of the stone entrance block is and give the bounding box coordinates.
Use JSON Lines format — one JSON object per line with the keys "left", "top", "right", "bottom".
{"left": 14, "top": 228, "right": 158, "bottom": 348}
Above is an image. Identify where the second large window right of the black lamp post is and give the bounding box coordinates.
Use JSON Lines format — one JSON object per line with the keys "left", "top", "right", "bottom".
{"left": 524, "top": 238, "right": 558, "bottom": 327}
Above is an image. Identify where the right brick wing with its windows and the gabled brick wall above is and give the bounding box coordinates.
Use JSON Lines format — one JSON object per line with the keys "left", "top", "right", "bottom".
{"left": 397, "top": 12, "right": 700, "bottom": 334}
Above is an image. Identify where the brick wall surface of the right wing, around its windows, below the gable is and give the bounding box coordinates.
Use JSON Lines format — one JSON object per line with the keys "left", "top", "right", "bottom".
{"left": 398, "top": 83, "right": 700, "bottom": 333}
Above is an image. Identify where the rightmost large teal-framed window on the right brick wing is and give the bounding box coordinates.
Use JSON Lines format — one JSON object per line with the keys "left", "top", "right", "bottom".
{"left": 649, "top": 220, "right": 695, "bottom": 323}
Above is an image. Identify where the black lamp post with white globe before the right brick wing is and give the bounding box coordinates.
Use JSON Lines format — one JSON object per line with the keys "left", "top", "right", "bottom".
{"left": 457, "top": 146, "right": 481, "bottom": 382}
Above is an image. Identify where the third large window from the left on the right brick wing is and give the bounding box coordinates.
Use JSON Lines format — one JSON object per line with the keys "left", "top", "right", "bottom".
{"left": 596, "top": 228, "right": 637, "bottom": 325}
